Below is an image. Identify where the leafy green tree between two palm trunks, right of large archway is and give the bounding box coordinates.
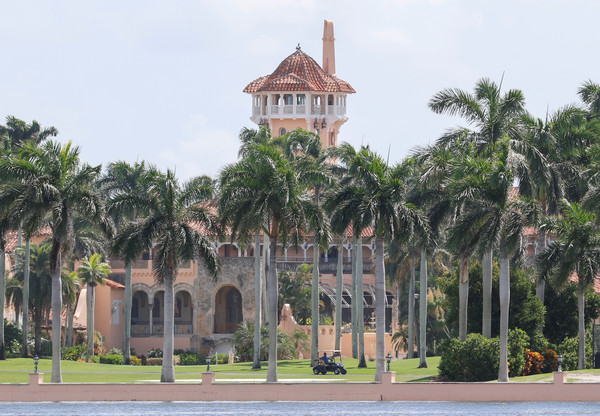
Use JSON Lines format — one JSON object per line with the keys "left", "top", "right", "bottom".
{"left": 277, "top": 264, "right": 312, "bottom": 325}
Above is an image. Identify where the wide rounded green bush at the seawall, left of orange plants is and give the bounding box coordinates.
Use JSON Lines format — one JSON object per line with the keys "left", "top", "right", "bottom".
{"left": 439, "top": 334, "right": 500, "bottom": 381}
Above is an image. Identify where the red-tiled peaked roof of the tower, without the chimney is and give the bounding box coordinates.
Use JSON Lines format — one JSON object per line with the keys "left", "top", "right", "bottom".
{"left": 244, "top": 45, "right": 356, "bottom": 94}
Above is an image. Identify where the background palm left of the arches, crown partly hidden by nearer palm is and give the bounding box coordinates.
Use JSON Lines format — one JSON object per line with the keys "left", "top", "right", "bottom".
{"left": 100, "top": 161, "right": 157, "bottom": 364}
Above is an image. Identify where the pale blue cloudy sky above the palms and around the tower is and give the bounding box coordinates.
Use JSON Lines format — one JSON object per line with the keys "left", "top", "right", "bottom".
{"left": 0, "top": 0, "right": 600, "bottom": 180}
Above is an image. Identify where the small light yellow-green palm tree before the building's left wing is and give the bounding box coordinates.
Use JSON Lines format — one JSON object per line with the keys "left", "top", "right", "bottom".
{"left": 77, "top": 253, "right": 110, "bottom": 360}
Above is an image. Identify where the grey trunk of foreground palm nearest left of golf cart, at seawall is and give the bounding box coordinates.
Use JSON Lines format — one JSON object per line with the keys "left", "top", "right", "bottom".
{"left": 267, "top": 223, "right": 279, "bottom": 383}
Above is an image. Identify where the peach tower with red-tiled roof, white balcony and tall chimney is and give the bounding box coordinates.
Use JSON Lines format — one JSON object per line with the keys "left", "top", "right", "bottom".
{"left": 244, "top": 20, "right": 356, "bottom": 147}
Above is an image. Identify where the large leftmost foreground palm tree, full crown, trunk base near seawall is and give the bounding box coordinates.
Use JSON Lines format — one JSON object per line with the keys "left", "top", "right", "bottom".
{"left": 0, "top": 141, "right": 112, "bottom": 383}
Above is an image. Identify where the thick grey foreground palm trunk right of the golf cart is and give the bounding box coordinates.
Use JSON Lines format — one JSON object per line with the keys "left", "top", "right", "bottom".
{"left": 375, "top": 236, "right": 385, "bottom": 382}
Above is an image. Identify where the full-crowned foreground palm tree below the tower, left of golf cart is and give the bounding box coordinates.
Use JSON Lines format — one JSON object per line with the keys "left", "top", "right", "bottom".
{"left": 219, "top": 135, "right": 315, "bottom": 382}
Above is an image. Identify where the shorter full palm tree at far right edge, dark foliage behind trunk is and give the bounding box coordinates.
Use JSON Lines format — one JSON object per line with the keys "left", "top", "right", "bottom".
{"left": 538, "top": 200, "right": 600, "bottom": 370}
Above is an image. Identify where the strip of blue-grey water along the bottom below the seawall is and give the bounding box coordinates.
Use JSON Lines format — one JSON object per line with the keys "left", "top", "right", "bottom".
{"left": 0, "top": 402, "right": 600, "bottom": 416}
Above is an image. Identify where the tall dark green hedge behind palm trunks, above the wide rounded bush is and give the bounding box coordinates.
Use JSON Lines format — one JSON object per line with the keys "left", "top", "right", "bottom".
{"left": 438, "top": 258, "right": 544, "bottom": 336}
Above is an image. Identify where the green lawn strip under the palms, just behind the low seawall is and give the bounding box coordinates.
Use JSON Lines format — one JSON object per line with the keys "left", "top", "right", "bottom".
{"left": 0, "top": 357, "right": 439, "bottom": 383}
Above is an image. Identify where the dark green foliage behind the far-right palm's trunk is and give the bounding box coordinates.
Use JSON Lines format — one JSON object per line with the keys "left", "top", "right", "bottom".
{"left": 538, "top": 283, "right": 600, "bottom": 344}
